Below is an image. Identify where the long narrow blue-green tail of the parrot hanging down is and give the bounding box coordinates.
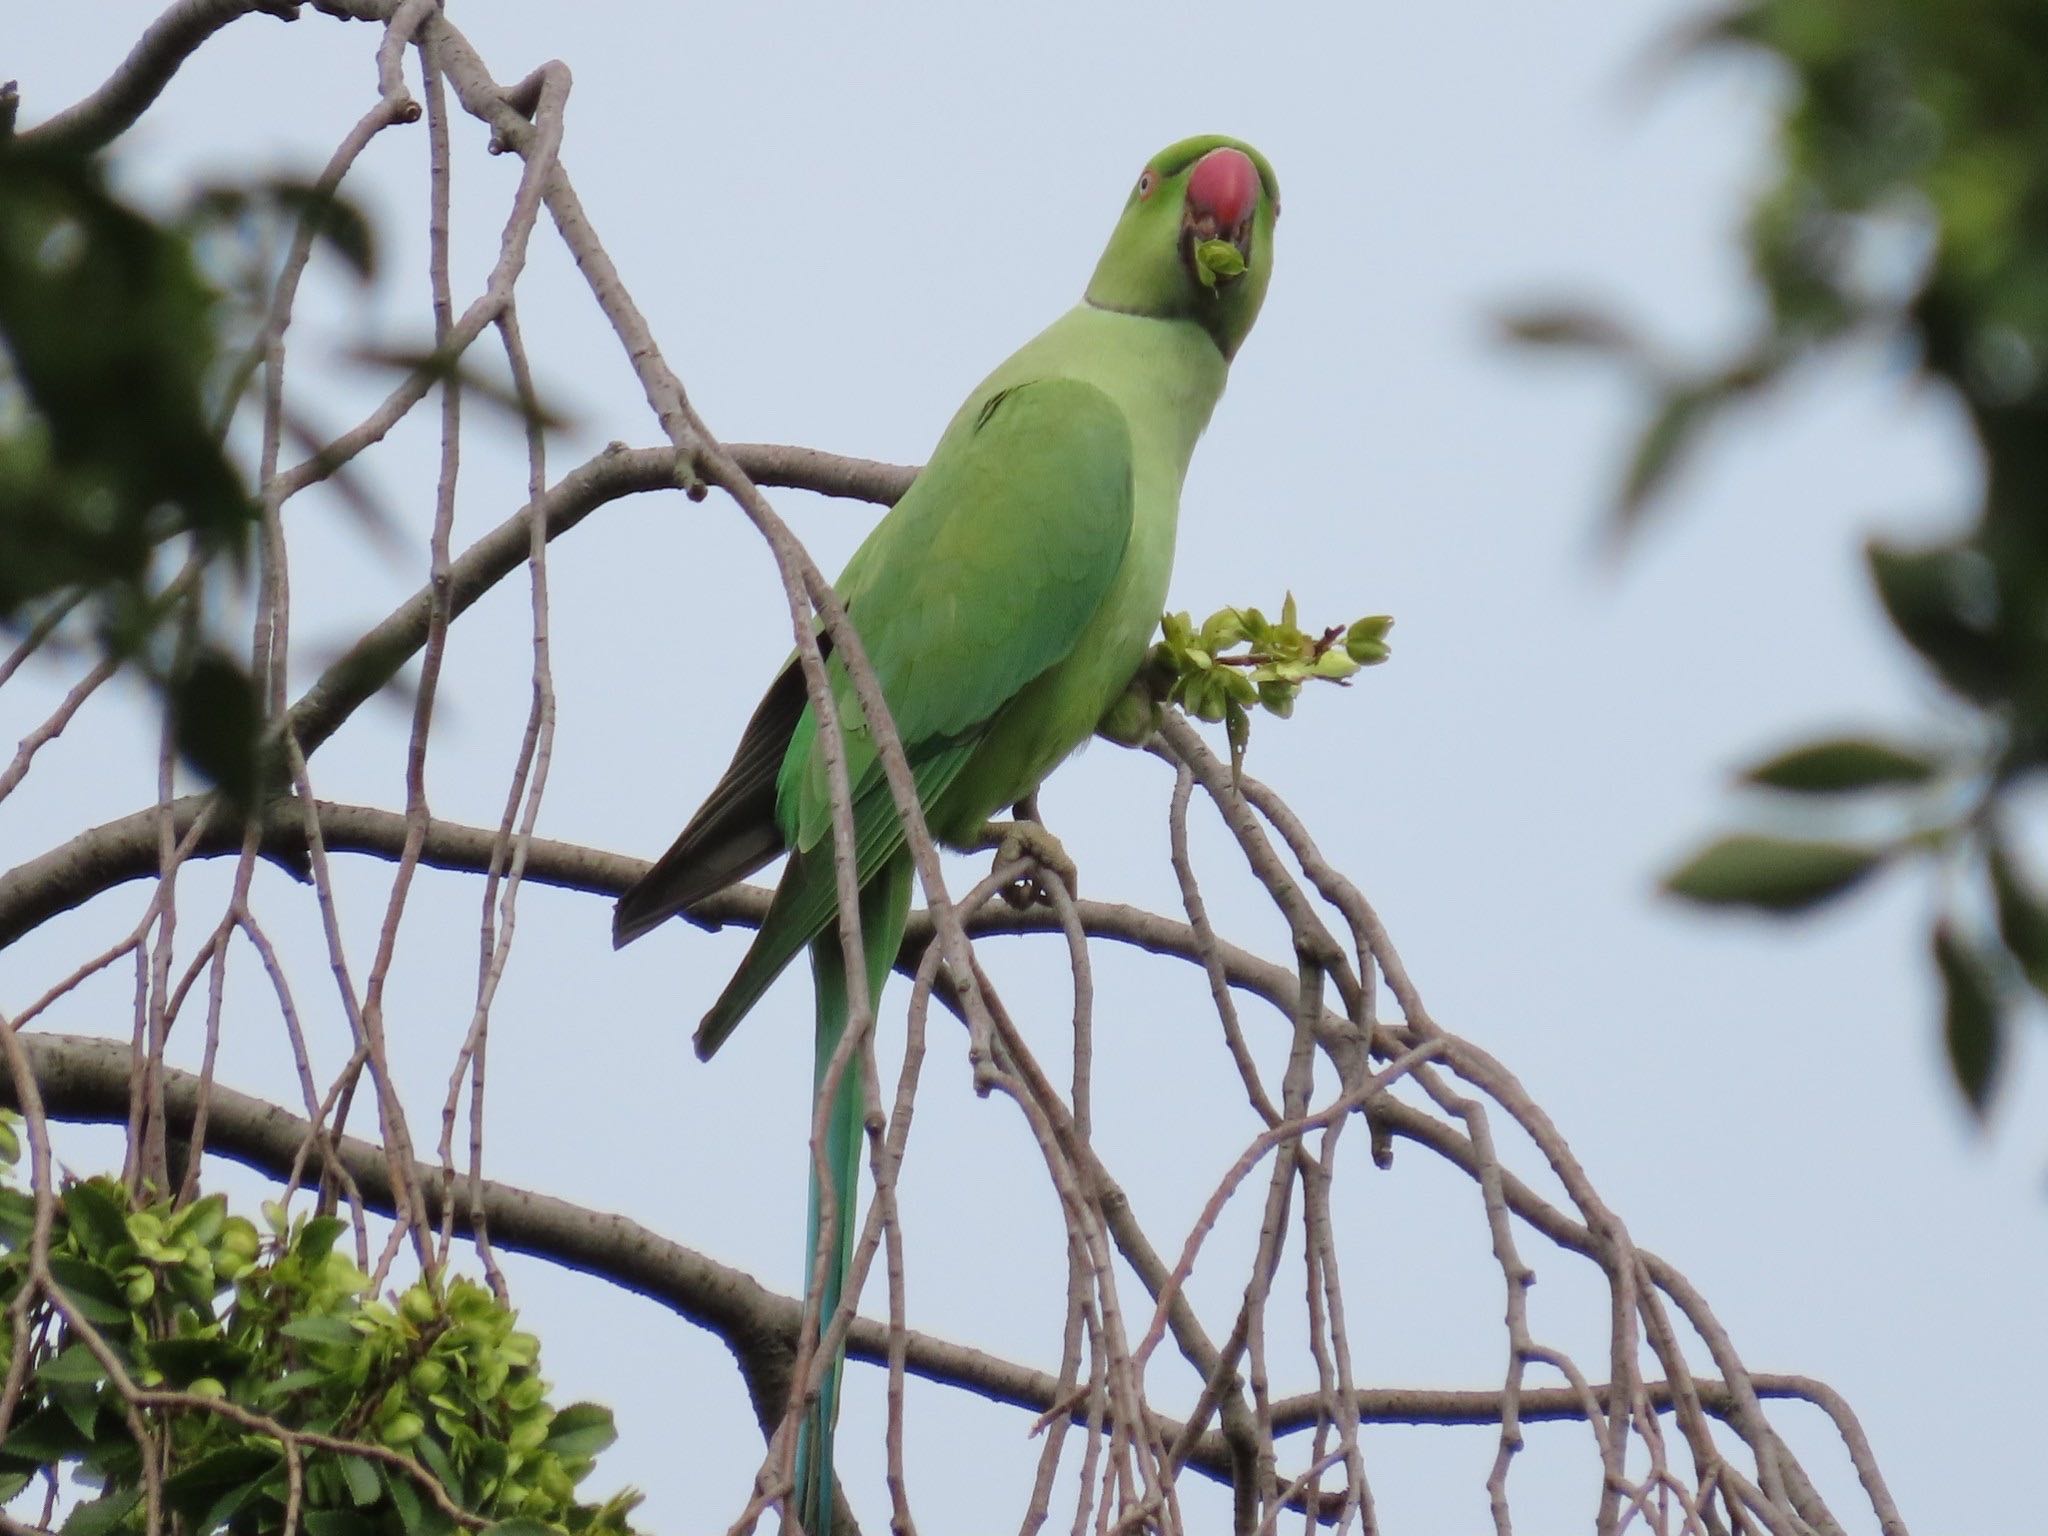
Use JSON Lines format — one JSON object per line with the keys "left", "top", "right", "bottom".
{"left": 797, "top": 852, "right": 909, "bottom": 1536}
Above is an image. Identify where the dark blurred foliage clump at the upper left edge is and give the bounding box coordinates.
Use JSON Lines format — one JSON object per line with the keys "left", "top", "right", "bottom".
{"left": 0, "top": 139, "right": 272, "bottom": 799}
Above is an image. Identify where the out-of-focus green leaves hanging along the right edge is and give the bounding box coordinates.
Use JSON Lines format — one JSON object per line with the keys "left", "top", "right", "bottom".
{"left": 1513, "top": 0, "right": 2048, "bottom": 1112}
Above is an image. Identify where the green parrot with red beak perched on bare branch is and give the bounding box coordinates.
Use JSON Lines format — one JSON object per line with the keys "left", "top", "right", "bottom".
{"left": 612, "top": 135, "right": 1280, "bottom": 1536}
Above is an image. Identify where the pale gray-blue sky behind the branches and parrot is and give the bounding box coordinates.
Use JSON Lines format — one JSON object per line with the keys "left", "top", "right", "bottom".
{"left": 0, "top": 0, "right": 2048, "bottom": 1532}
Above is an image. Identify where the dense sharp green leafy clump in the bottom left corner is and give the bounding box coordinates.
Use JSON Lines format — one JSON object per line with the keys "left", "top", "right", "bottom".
{"left": 0, "top": 1126, "right": 637, "bottom": 1536}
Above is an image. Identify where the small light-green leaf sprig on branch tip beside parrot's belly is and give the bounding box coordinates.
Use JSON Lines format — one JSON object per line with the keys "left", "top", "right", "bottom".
{"left": 1147, "top": 592, "right": 1395, "bottom": 774}
